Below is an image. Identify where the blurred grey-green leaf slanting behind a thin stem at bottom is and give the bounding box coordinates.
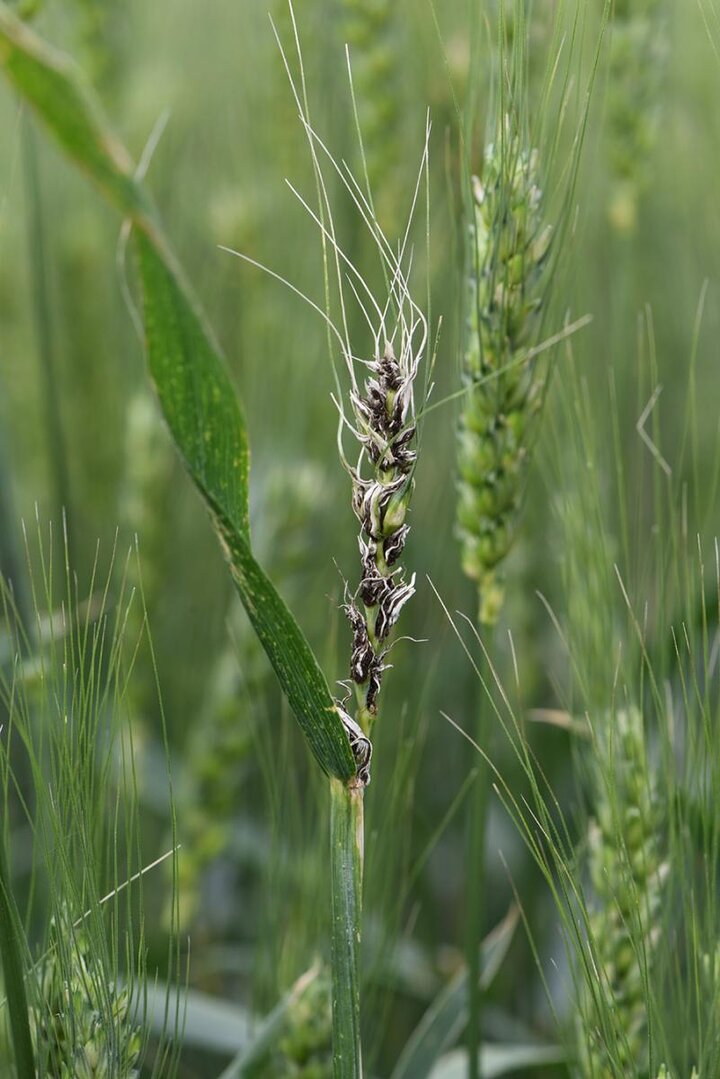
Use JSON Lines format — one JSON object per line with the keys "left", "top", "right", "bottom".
{"left": 392, "top": 907, "right": 518, "bottom": 1079}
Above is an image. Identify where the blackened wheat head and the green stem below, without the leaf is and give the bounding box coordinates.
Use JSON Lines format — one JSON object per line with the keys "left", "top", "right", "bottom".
{"left": 331, "top": 208, "right": 427, "bottom": 1079}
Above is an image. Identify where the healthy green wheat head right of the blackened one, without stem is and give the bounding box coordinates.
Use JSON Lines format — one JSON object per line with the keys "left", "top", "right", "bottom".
{"left": 458, "top": 118, "right": 551, "bottom": 625}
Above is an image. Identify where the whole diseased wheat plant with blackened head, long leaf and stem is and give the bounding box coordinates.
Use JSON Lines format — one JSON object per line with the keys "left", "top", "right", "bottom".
{"left": 0, "top": 10, "right": 426, "bottom": 1076}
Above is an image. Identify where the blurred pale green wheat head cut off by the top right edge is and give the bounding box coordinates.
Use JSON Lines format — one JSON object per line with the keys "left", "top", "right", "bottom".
{"left": 607, "top": 0, "right": 667, "bottom": 232}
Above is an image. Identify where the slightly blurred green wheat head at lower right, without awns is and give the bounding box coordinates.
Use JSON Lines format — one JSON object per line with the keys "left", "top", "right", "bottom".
{"left": 578, "top": 708, "right": 668, "bottom": 1079}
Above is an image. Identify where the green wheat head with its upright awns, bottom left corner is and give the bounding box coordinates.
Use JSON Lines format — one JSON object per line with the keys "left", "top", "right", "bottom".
{"left": 0, "top": 520, "right": 178, "bottom": 1079}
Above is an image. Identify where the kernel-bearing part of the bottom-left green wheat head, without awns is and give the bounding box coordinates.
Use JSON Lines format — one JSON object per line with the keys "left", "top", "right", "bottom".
{"left": 30, "top": 916, "right": 141, "bottom": 1079}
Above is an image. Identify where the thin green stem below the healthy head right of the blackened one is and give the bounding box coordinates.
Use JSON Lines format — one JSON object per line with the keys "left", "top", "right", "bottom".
{"left": 465, "top": 638, "right": 491, "bottom": 1079}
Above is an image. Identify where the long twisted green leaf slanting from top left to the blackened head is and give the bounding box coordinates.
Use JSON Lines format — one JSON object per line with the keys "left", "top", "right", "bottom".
{"left": 0, "top": 6, "right": 355, "bottom": 781}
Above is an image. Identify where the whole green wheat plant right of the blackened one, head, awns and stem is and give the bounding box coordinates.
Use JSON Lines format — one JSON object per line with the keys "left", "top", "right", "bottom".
{"left": 457, "top": 3, "right": 604, "bottom": 1079}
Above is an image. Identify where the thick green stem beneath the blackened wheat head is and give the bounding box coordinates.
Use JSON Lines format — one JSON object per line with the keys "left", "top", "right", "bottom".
{"left": 330, "top": 779, "right": 364, "bottom": 1079}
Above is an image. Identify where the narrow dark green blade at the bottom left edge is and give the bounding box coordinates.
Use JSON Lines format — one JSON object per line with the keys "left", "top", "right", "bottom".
{"left": 0, "top": 837, "right": 36, "bottom": 1079}
